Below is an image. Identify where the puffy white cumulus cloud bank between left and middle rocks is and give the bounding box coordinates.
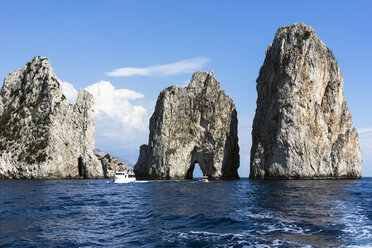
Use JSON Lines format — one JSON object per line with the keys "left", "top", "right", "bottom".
{"left": 61, "top": 81, "right": 150, "bottom": 163}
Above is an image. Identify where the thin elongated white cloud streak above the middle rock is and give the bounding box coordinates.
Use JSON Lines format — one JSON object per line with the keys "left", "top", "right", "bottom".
{"left": 106, "top": 57, "right": 209, "bottom": 77}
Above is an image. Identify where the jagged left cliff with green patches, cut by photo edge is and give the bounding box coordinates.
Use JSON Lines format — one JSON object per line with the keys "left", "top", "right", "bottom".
{"left": 0, "top": 57, "right": 103, "bottom": 179}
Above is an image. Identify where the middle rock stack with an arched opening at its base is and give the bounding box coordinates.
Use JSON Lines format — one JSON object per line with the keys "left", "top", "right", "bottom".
{"left": 134, "top": 72, "right": 239, "bottom": 179}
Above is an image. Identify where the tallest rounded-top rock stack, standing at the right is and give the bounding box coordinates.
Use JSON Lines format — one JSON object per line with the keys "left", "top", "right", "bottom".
{"left": 250, "top": 23, "right": 362, "bottom": 179}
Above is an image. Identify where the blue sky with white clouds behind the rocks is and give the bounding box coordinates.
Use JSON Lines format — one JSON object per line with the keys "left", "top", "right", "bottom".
{"left": 0, "top": 0, "right": 372, "bottom": 177}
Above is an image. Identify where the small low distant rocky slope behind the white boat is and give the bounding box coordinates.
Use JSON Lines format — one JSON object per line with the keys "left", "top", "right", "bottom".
{"left": 93, "top": 149, "right": 133, "bottom": 178}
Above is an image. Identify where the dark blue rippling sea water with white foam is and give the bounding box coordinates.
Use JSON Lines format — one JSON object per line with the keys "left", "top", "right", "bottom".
{"left": 0, "top": 178, "right": 372, "bottom": 247}
